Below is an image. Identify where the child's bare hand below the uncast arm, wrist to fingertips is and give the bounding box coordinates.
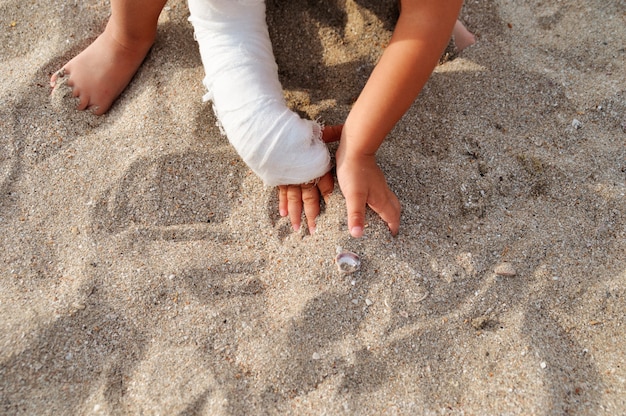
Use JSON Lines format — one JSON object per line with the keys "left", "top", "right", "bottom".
{"left": 337, "top": 145, "right": 400, "bottom": 238}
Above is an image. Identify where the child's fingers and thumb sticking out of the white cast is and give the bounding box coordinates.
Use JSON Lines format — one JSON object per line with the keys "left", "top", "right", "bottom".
{"left": 278, "top": 126, "right": 343, "bottom": 234}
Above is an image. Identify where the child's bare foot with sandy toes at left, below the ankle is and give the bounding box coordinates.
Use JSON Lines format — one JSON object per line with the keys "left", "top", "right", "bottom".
{"left": 50, "top": 24, "right": 154, "bottom": 115}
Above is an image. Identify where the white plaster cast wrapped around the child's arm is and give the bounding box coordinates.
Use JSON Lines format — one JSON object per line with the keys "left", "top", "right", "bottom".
{"left": 189, "top": 0, "right": 331, "bottom": 186}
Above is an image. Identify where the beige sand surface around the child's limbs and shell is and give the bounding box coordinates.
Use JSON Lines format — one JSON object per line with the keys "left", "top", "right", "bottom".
{"left": 0, "top": 0, "right": 626, "bottom": 415}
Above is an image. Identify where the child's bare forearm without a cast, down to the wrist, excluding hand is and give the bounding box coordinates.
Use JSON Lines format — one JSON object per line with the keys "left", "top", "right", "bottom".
{"left": 342, "top": 0, "right": 462, "bottom": 155}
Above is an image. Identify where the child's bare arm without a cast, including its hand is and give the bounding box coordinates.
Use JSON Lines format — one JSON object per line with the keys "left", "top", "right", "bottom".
{"left": 337, "top": 0, "right": 463, "bottom": 237}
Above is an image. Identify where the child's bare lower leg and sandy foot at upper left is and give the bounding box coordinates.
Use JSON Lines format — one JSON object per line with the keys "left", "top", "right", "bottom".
{"left": 50, "top": 0, "right": 167, "bottom": 115}
